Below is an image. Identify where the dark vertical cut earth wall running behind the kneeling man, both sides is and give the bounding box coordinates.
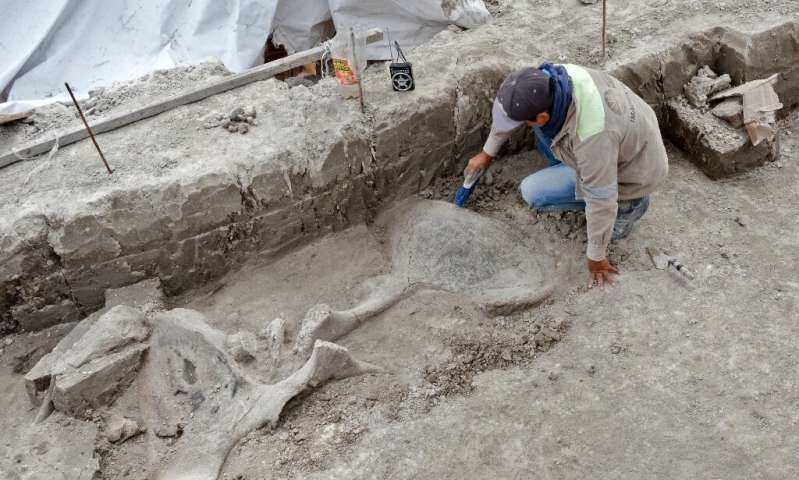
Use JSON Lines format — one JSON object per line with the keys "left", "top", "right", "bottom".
{"left": 0, "top": 22, "right": 799, "bottom": 335}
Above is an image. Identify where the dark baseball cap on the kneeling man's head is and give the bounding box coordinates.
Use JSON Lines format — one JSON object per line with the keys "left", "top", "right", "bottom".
{"left": 493, "top": 67, "right": 552, "bottom": 130}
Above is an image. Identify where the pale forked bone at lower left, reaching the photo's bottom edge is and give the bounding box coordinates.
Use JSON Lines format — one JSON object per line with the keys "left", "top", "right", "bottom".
{"left": 144, "top": 309, "right": 379, "bottom": 480}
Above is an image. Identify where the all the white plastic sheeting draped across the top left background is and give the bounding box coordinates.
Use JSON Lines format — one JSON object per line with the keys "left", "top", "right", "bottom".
{"left": 0, "top": 0, "right": 491, "bottom": 105}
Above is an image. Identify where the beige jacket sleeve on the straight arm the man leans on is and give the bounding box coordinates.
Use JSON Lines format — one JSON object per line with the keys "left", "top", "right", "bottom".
{"left": 574, "top": 131, "right": 619, "bottom": 260}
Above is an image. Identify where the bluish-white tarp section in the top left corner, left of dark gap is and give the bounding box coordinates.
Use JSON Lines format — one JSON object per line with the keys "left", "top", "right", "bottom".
{"left": 0, "top": 0, "right": 278, "bottom": 100}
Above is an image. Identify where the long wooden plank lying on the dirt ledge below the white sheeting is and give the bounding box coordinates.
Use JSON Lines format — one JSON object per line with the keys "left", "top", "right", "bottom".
{"left": 0, "top": 28, "right": 383, "bottom": 169}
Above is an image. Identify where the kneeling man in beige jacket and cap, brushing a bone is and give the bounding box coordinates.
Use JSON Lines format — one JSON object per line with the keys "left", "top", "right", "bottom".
{"left": 466, "top": 63, "right": 668, "bottom": 285}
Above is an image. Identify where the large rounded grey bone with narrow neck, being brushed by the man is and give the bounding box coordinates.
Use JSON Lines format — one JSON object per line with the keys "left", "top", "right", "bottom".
{"left": 295, "top": 201, "right": 553, "bottom": 356}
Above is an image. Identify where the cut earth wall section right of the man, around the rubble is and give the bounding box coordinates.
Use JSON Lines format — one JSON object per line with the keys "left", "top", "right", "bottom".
{"left": 612, "top": 22, "right": 799, "bottom": 179}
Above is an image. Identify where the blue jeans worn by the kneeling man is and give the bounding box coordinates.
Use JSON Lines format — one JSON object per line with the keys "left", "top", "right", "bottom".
{"left": 519, "top": 135, "right": 649, "bottom": 240}
